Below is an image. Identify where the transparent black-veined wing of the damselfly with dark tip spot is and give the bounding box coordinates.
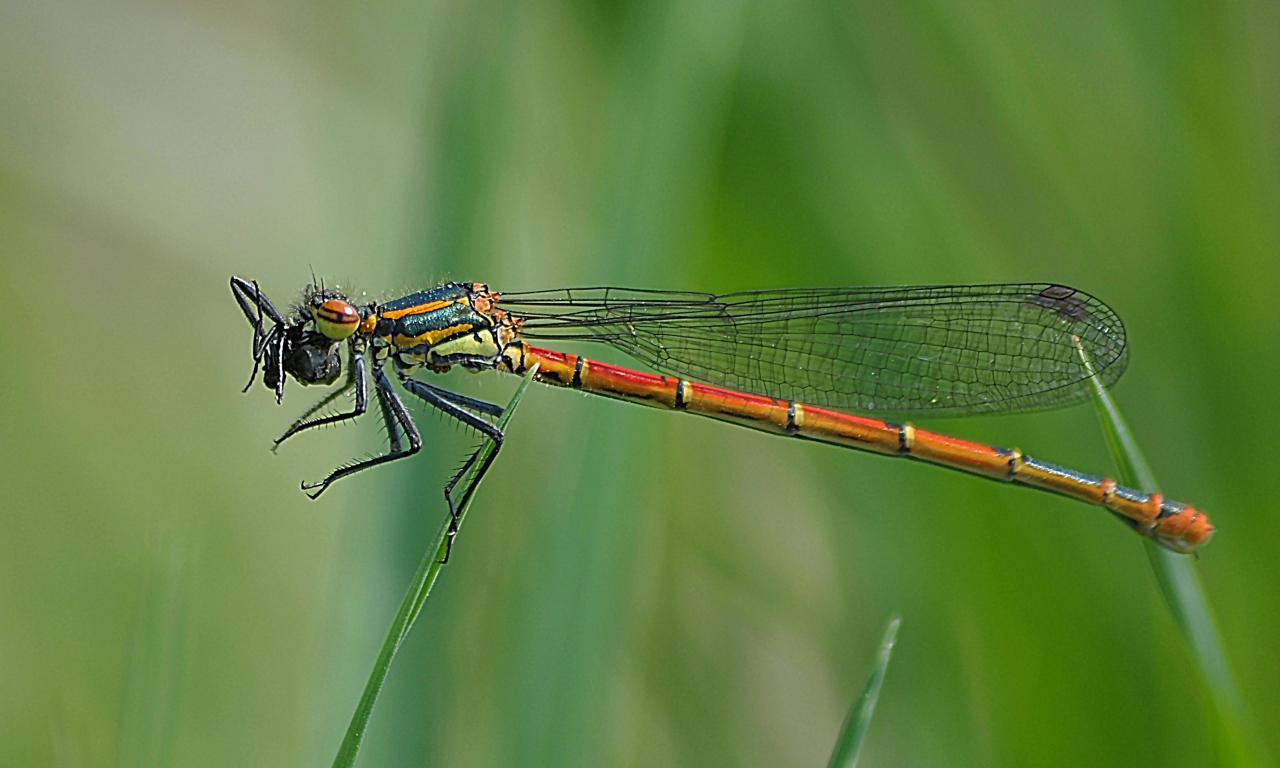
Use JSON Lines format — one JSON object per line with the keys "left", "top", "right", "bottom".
{"left": 500, "top": 284, "right": 1128, "bottom": 415}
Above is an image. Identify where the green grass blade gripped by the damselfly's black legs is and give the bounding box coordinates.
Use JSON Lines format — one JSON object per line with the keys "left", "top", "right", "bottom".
{"left": 333, "top": 365, "right": 538, "bottom": 768}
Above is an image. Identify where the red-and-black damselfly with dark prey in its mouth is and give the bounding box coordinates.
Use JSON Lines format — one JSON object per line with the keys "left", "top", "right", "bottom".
{"left": 232, "top": 278, "right": 1213, "bottom": 559}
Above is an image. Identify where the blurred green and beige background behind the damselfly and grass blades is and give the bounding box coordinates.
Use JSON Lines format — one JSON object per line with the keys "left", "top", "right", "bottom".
{"left": 0, "top": 0, "right": 1280, "bottom": 767}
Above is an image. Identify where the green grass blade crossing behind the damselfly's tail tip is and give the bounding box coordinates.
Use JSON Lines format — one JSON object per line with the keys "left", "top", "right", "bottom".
{"left": 1085, "top": 350, "right": 1271, "bottom": 765}
